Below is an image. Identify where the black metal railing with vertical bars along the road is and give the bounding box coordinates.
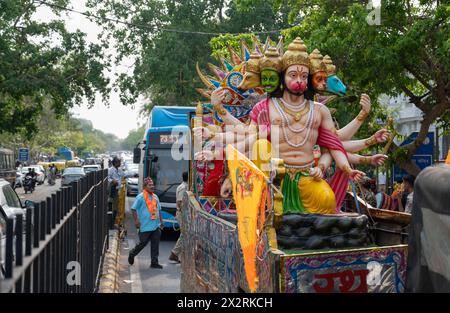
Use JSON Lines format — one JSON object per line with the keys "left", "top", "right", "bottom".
{"left": 0, "top": 170, "right": 108, "bottom": 293}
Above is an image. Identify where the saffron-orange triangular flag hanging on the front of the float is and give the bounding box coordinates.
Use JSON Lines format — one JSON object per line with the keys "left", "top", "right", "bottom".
{"left": 227, "top": 145, "right": 267, "bottom": 292}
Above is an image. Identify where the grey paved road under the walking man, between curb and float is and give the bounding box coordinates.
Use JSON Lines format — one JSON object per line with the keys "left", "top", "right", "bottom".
{"left": 120, "top": 197, "right": 181, "bottom": 293}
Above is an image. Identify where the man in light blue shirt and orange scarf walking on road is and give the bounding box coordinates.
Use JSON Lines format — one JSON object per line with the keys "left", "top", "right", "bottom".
{"left": 128, "top": 177, "right": 164, "bottom": 269}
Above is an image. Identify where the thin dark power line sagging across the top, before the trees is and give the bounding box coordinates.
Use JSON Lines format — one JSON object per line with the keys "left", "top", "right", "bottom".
{"left": 38, "top": 0, "right": 292, "bottom": 36}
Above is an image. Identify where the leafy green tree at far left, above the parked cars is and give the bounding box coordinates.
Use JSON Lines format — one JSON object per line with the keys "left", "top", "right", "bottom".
{"left": 0, "top": 0, "right": 109, "bottom": 138}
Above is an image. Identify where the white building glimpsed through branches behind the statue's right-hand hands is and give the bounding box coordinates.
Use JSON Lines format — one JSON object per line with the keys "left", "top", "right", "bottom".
{"left": 378, "top": 95, "right": 450, "bottom": 160}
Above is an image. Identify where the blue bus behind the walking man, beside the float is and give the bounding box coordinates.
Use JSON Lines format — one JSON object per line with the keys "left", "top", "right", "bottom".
{"left": 134, "top": 106, "right": 195, "bottom": 228}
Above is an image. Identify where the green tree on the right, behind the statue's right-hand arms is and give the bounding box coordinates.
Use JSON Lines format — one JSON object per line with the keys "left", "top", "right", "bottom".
{"left": 234, "top": 0, "right": 450, "bottom": 175}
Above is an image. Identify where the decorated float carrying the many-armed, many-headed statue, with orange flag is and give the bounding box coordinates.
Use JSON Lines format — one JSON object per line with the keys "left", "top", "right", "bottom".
{"left": 181, "top": 38, "right": 410, "bottom": 293}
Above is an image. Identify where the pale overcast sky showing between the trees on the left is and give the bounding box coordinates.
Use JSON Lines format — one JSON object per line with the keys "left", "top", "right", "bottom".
{"left": 34, "top": 0, "right": 144, "bottom": 138}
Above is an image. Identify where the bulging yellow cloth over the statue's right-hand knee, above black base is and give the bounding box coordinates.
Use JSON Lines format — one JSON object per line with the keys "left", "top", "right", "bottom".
{"left": 298, "top": 177, "right": 336, "bottom": 214}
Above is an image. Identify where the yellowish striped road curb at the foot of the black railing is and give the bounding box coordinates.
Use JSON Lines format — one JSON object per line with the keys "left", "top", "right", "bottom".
{"left": 98, "top": 230, "right": 120, "bottom": 293}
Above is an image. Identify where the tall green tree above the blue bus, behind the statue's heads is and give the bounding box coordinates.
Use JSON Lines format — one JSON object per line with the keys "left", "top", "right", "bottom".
{"left": 89, "top": 0, "right": 287, "bottom": 110}
